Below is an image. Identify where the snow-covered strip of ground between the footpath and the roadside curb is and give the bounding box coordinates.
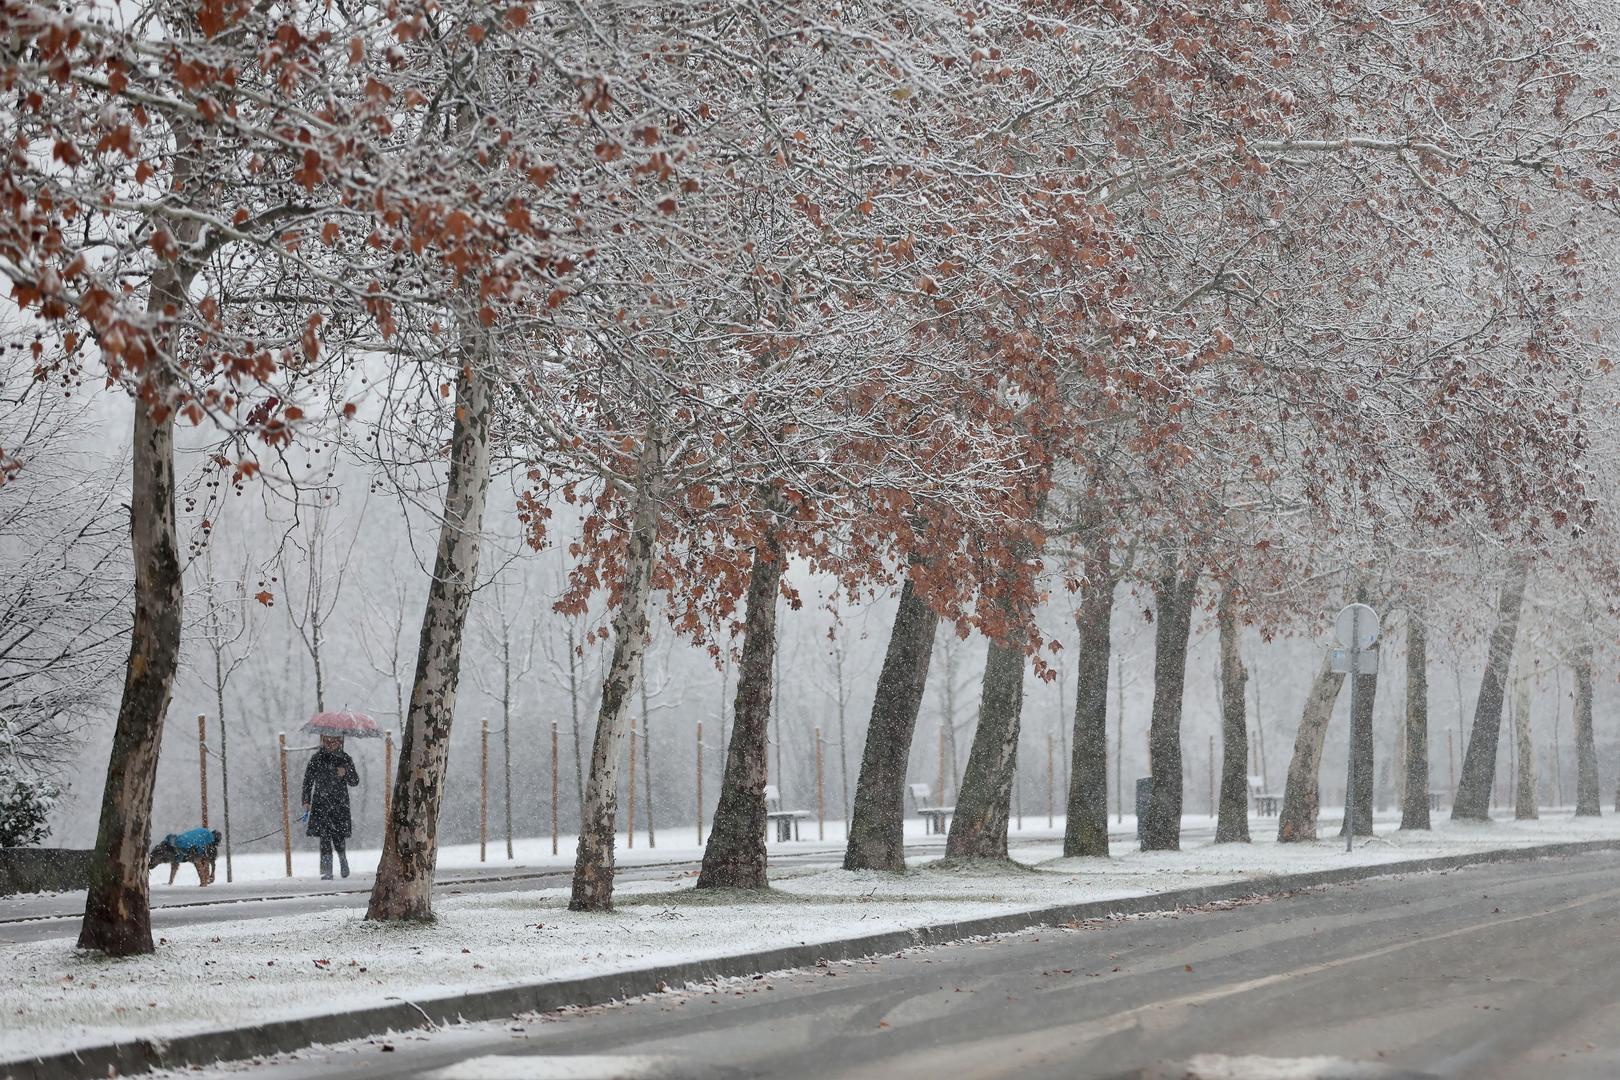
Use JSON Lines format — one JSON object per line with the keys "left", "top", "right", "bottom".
{"left": 0, "top": 813, "right": 1620, "bottom": 1059}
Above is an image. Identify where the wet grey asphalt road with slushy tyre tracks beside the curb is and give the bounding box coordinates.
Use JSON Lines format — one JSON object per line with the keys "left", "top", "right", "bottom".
{"left": 188, "top": 855, "right": 1620, "bottom": 1080}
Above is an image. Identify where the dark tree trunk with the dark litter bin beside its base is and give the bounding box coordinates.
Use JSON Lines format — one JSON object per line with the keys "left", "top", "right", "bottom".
{"left": 1142, "top": 570, "right": 1199, "bottom": 852}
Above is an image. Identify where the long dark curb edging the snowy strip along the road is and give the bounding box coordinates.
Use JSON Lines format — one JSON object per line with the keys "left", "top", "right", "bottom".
{"left": 0, "top": 840, "right": 1620, "bottom": 1080}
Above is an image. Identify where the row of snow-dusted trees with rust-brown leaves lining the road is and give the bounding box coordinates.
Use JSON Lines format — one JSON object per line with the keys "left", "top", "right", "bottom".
{"left": 9, "top": 0, "right": 1620, "bottom": 954}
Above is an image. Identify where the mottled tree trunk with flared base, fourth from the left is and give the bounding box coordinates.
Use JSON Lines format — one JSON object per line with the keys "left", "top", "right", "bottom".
{"left": 698, "top": 539, "right": 782, "bottom": 889}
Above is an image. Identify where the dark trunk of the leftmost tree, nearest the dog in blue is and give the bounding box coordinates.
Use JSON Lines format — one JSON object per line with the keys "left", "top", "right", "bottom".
{"left": 79, "top": 132, "right": 201, "bottom": 957}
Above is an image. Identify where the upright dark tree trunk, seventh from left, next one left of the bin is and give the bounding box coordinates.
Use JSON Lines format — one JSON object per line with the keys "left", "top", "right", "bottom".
{"left": 1063, "top": 557, "right": 1115, "bottom": 858}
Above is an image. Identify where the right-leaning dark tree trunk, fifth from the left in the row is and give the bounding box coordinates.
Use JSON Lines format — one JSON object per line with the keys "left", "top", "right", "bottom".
{"left": 844, "top": 578, "right": 940, "bottom": 871}
